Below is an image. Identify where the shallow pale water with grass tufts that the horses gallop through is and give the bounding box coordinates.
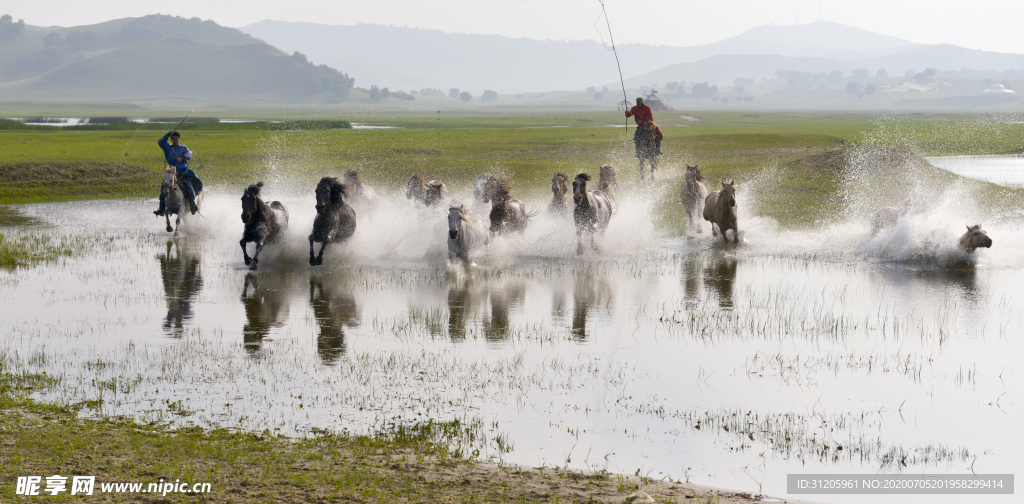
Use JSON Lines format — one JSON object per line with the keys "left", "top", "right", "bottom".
{"left": 0, "top": 186, "right": 1024, "bottom": 502}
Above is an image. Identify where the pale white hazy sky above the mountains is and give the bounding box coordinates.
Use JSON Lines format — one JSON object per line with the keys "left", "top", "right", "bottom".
{"left": 8, "top": 0, "right": 1024, "bottom": 53}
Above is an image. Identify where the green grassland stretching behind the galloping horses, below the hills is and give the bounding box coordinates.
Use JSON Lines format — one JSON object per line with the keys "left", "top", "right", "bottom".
{"left": 0, "top": 111, "right": 1024, "bottom": 232}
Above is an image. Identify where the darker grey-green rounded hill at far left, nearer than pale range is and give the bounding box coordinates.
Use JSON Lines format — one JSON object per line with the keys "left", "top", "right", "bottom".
{"left": 0, "top": 14, "right": 352, "bottom": 103}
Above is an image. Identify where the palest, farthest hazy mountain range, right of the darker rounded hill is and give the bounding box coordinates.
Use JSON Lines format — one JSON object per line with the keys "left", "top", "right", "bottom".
{"left": 242, "top": 20, "right": 929, "bottom": 94}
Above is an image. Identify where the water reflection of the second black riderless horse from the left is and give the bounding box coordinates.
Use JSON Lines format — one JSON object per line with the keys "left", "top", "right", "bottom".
{"left": 309, "top": 277, "right": 359, "bottom": 366}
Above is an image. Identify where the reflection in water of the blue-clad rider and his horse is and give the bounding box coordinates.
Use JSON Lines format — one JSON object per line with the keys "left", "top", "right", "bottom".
{"left": 157, "top": 240, "right": 203, "bottom": 336}
